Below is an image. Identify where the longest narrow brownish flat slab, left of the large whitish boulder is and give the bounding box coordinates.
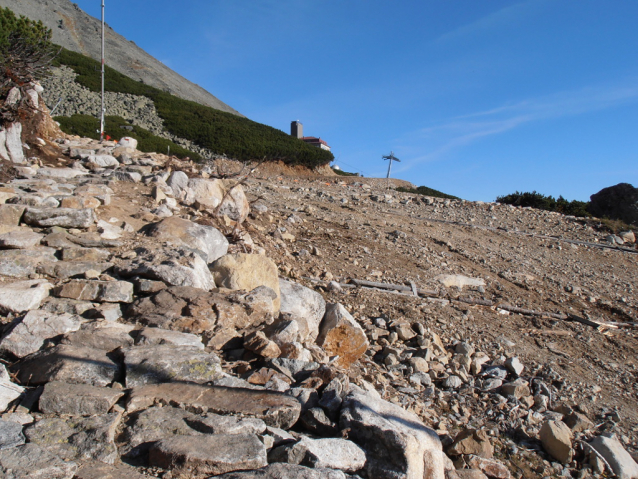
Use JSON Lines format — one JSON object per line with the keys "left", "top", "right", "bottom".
{"left": 127, "top": 383, "right": 301, "bottom": 429}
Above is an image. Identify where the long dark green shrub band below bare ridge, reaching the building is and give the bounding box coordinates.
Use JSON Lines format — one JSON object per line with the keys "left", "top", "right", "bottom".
{"left": 57, "top": 50, "right": 334, "bottom": 168}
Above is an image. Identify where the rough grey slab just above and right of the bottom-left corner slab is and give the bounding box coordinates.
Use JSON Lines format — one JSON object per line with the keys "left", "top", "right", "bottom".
{"left": 24, "top": 413, "right": 121, "bottom": 464}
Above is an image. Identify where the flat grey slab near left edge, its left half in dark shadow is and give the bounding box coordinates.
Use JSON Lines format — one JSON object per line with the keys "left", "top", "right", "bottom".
{"left": 12, "top": 344, "right": 120, "bottom": 386}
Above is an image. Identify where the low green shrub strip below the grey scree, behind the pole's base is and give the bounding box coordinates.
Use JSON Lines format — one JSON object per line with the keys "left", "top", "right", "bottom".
{"left": 54, "top": 115, "right": 202, "bottom": 160}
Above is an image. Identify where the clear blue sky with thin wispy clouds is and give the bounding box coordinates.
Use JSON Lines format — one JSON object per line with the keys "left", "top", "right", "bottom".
{"left": 75, "top": 0, "right": 638, "bottom": 201}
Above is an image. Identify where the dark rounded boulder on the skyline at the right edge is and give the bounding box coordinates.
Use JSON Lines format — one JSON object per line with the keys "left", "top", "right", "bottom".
{"left": 587, "top": 183, "right": 638, "bottom": 225}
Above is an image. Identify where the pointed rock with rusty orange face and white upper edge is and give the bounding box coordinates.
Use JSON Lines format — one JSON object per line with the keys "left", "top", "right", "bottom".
{"left": 317, "top": 304, "right": 369, "bottom": 368}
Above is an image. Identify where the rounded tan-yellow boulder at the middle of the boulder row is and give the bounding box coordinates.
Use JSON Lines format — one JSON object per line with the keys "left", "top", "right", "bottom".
{"left": 210, "top": 253, "right": 281, "bottom": 311}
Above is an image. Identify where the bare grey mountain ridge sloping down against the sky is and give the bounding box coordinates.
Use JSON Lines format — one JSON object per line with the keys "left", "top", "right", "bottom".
{"left": 0, "top": 0, "right": 243, "bottom": 116}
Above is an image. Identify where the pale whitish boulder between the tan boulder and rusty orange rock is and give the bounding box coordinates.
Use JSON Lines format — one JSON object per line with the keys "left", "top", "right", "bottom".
{"left": 279, "top": 279, "right": 326, "bottom": 342}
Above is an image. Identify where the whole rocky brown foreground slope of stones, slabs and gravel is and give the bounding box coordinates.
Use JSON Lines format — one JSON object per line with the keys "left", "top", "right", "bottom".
{"left": 0, "top": 89, "right": 638, "bottom": 479}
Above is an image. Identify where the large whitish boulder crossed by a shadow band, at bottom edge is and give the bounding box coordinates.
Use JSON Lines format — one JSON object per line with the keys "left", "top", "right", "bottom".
{"left": 340, "top": 386, "right": 447, "bottom": 479}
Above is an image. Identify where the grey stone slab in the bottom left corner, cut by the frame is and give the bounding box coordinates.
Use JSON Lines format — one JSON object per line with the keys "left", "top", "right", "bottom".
{"left": 0, "top": 444, "right": 78, "bottom": 479}
